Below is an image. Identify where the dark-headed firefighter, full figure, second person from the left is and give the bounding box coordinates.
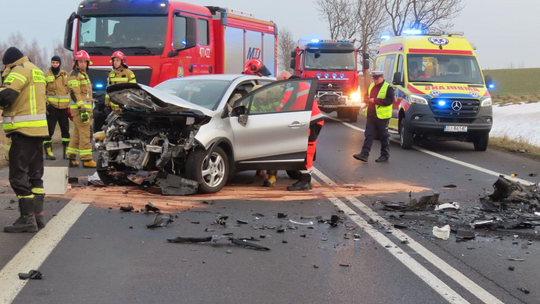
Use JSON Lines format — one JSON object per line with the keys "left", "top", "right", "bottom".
{"left": 43, "top": 56, "right": 69, "bottom": 160}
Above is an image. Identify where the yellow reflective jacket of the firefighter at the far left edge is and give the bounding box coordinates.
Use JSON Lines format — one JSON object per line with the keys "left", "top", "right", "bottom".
{"left": 0, "top": 56, "right": 49, "bottom": 137}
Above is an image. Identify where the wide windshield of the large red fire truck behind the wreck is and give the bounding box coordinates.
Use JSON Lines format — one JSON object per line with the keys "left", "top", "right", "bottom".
{"left": 77, "top": 16, "right": 167, "bottom": 56}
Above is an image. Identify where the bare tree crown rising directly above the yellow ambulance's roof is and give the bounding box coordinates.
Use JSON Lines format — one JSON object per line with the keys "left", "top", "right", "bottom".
{"left": 409, "top": 0, "right": 464, "bottom": 30}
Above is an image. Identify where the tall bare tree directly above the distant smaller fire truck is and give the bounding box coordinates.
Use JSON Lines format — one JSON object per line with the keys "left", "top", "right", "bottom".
{"left": 315, "top": 0, "right": 359, "bottom": 39}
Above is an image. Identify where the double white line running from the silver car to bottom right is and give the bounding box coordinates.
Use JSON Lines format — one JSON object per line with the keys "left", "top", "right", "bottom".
{"left": 313, "top": 168, "right": 503, "bottom": 304}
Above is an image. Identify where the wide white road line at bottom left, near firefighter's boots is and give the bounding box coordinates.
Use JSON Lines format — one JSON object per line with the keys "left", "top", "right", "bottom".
{"left": 0, "top": 198, "right": 88, "bottom": 304}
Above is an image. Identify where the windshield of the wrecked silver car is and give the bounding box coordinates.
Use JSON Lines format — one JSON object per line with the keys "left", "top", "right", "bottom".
{"left": 155, "top": 78, "right": 230, "bottom": 110}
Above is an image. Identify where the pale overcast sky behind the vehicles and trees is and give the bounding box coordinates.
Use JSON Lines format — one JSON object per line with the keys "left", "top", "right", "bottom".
{"left": 0, "top": 0, "right": 540, "bottom": 69}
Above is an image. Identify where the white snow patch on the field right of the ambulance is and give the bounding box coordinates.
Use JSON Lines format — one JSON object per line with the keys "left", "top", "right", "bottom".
{"left": 490, "top": 102, "right": 540, "bottom": 147}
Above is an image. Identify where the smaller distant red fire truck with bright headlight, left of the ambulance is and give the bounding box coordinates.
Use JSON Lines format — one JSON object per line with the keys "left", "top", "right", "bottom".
{"left": 291, "top": 39, "right": 361, "bottom": 122}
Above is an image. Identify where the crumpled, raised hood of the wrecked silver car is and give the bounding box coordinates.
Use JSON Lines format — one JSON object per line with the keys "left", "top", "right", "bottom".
{"left": 107, "top": 83, "right": 213, "bottom": 116}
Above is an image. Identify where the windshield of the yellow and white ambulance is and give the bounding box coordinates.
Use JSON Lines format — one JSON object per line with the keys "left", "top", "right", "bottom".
{"left": 407, "top": 54, "right": 484, "bottom": 84}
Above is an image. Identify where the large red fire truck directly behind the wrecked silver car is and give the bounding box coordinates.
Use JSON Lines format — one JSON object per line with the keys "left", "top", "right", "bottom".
{"left": 64, "top": 0, "right": 277, "bottom": 127}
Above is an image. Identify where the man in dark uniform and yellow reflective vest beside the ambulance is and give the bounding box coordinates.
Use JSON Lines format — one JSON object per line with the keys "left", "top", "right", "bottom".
{"left": 353, "top": 71, "right": 394, "bottom": 163}
